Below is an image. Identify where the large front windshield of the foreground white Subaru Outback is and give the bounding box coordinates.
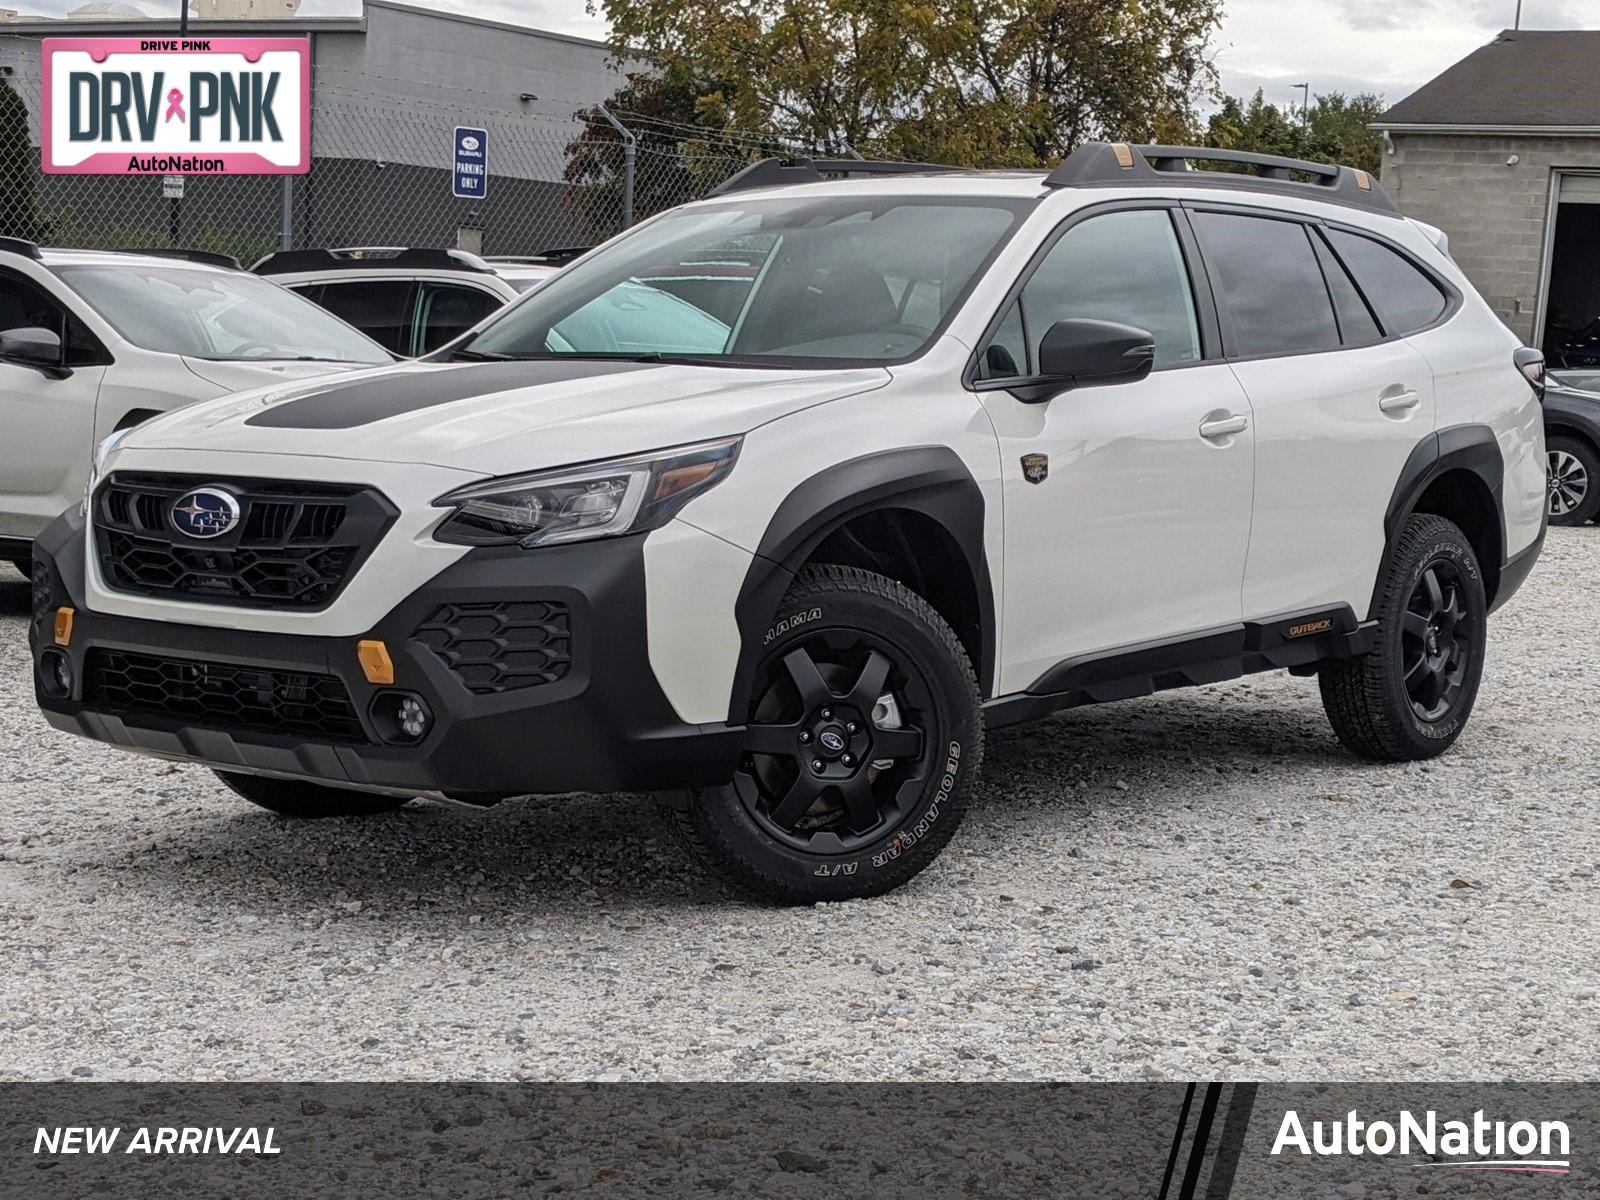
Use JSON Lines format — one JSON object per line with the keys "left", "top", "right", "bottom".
{"left": 456, "top": 197, "right": 1029, "bottom": 366}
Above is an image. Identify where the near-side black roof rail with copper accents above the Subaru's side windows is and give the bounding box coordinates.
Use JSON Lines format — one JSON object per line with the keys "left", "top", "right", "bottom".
{"left": 1045, "top": 142, "right": 1400, "bottom": 214}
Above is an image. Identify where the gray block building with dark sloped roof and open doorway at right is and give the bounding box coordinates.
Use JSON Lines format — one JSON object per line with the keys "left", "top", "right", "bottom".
{"left": 1378, "top": 30, "right": 1600, "bottom": 356}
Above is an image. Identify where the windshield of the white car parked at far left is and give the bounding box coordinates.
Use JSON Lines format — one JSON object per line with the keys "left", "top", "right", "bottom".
{"left": 56, "top": 262, "right": 394, "bottom": 363}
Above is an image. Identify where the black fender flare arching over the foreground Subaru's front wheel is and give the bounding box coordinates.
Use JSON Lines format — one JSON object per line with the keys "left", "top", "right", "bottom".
{"left": 728, "top": 446, "right": 995, "bottom": 725}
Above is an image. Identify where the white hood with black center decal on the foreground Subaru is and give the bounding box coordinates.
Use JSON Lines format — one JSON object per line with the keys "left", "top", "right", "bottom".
{"left": 118, "top": 360, "right": 890, "bottom": 475}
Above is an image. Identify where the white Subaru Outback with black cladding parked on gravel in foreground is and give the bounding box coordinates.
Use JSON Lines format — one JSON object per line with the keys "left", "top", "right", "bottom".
{"left": 32, "top": 144, "right": 1546, "bottom": 902}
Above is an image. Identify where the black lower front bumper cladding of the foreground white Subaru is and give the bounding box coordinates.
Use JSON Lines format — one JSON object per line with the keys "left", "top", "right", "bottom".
{"left": 30, "top": 514, "right": 741, "bottom": 802}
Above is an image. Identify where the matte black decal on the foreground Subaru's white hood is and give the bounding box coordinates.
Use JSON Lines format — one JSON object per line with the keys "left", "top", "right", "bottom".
{"left": 245, "top": 358, "right": 651, "bottom": 429}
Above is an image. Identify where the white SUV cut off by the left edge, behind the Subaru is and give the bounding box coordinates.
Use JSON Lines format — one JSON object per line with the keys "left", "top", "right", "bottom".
{"left": 0, "top": 238, "right": 394, "bottom": 573}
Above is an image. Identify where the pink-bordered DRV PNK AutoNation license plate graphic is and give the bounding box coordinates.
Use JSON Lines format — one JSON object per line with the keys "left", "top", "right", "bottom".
{"left": 40, "top": 37, "right": 310, "bottom": 174}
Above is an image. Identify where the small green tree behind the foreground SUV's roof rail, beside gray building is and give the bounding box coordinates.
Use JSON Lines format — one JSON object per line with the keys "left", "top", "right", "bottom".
{"left": 1206, "top": 91, "right": 1387, "bottom": 174}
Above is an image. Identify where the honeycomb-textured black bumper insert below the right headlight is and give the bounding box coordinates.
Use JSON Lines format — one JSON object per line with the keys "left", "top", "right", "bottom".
{"left": 413, "top": 600, "right": 573, "bottom": 694}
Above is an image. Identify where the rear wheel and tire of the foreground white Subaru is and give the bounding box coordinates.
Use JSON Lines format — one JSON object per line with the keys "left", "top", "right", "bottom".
{"left": 1318, "top": 515, "right": 1488, "bottom": 762}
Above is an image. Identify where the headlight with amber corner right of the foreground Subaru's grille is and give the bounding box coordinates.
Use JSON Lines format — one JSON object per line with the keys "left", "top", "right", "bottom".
{"left": 434, "top": 437, "right": 739, "bottom": 549}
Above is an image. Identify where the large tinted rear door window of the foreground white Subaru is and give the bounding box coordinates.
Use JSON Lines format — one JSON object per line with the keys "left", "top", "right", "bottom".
{"left": 1194, "top": 213, "right": 1339, "bottom": 358}
